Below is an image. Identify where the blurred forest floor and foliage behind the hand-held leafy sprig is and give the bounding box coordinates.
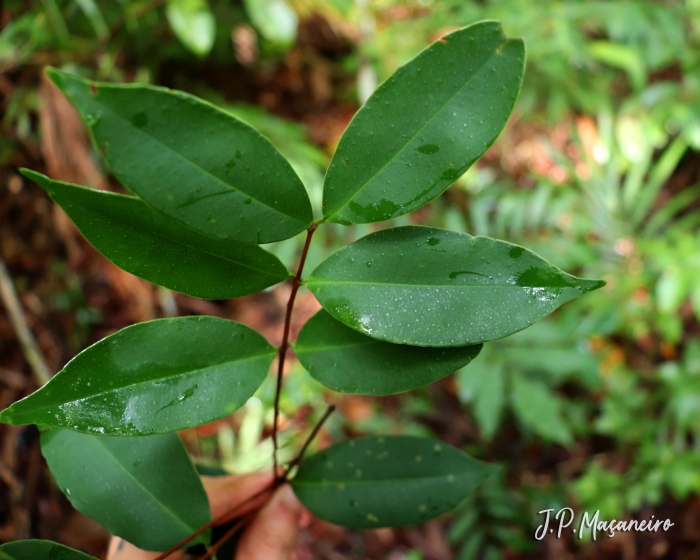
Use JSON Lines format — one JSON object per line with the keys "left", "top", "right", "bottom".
{"left": 0, "top": 0, "right": 700, "bottom": 560}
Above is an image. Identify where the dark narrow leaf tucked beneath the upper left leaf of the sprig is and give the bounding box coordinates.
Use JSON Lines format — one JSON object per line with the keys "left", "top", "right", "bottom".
{"left": 21, "top": 169, "right": 289, "bottom": 299}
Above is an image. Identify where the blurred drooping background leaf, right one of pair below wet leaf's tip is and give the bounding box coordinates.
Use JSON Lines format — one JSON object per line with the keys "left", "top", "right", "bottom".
{"left": 511, "top": 375, "right": 573, "bottom": 445}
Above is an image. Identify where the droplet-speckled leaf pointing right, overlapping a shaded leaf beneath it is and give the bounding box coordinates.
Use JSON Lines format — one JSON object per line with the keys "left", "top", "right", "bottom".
{"left": 306, "top": 226, "right": 605, "bottom": 346}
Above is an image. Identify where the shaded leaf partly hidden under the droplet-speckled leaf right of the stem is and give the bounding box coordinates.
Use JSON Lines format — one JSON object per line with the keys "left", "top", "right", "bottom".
{"left": 294, "top": 310, "right": 481, "bottom": 395}
